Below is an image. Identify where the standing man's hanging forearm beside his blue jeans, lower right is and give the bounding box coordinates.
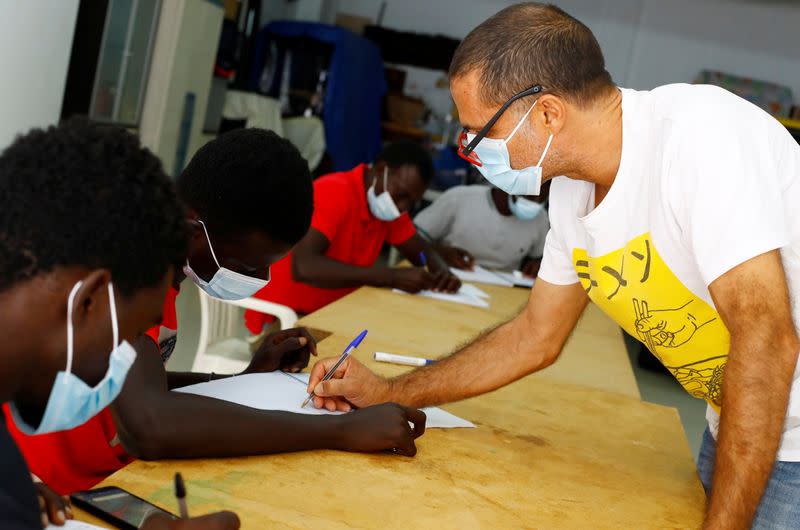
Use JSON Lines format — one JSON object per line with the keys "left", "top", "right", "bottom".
{"left": 705, "top": 333, "right": 798, "bottom": 529}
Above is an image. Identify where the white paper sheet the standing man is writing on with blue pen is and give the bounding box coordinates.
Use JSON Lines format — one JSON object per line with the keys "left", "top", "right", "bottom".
{"left": 174, "top": 372, "right": 475, "bottom": 429}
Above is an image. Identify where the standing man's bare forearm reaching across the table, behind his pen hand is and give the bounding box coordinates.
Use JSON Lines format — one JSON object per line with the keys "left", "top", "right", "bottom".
{"left": 388, "top": 312, "right": 563, "bottom": 407}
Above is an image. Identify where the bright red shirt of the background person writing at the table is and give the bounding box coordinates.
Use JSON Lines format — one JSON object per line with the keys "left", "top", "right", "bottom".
{"left": 245, "top": 164, "right": 416, "bottom": 333}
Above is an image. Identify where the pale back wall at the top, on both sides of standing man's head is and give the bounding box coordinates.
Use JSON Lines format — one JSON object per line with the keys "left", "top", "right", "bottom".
{"left": 336, "top": 0, "right": 800, "bottom": 97}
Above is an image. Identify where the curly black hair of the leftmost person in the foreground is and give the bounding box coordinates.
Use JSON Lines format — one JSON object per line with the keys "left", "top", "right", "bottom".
{"left": 0, "top": 119, "right": 188, "bottom": 296}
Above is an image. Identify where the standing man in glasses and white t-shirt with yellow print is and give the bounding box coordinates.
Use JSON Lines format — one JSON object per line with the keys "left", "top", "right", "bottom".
{"left": 310, "top": 4, "right": 800, "bottom": 529}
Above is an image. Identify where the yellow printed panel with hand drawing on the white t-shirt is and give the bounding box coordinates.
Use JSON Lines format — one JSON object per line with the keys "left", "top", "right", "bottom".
{"left": 573, "top": 234, "right": 730, "bottom": 412}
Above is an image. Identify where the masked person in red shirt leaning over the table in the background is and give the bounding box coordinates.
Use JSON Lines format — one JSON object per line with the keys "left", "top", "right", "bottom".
{"left": 245, "top": 142, "right": 461, "bottom": 333}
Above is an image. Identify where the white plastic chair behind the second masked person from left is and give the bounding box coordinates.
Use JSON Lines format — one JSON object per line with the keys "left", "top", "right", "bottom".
{"left": 192, "top": 287, "right": 297, "bottom": 374}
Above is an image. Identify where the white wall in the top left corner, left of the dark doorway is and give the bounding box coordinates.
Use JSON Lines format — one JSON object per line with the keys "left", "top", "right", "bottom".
{"left": 0, "top": 0, "right": 78, "bottom": 150}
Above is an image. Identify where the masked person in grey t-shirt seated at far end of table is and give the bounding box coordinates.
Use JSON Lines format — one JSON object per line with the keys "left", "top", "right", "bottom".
{"left": 414, "top": 182, "right": 550, "bottom": 278}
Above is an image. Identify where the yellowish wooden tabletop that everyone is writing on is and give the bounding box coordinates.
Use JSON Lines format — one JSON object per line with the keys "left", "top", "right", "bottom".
{"left": 84, "top": 286, "right": 705, "bottom": 529}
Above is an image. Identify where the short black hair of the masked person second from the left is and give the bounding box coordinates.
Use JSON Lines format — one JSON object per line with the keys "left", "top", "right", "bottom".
{"left": 177, "top": 129, "right": 314, "bottom": 245}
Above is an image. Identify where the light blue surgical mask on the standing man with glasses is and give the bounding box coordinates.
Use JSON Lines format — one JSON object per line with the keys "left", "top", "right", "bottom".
{"left": 467, "top": 100, "right": 553, "bottom": 195}
